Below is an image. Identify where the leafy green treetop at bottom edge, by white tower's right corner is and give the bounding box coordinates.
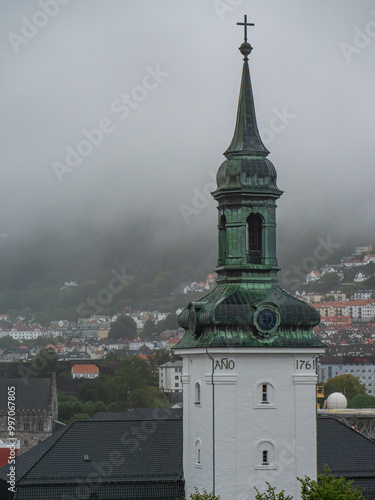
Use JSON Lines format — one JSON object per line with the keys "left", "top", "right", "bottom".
{"left": 297, "top": 468, "right": 365, "bottom": 500}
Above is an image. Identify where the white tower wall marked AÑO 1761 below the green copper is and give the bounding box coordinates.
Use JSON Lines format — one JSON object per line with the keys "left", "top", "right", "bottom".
{"left": 179, "top": 348, "right": 324, "bottom": 500}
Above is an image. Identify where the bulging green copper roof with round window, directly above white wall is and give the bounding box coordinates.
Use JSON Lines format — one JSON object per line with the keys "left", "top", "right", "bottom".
{"left": 175, "top": 282, "right": 324, "bottom": 349}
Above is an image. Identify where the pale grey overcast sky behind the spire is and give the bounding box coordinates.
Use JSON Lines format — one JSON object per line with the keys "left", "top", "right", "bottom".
{"left": 0, "top": 0, "right": 375, "bottom": 252}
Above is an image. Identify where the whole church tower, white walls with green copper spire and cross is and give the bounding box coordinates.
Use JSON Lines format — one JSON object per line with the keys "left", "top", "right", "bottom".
{"left": 175, "top": 16, "right": 324, "bottom": 500}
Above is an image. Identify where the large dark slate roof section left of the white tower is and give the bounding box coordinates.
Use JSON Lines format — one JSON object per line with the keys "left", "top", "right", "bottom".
{"left": 0, "top": 420, "right": 184, "bottom": 500}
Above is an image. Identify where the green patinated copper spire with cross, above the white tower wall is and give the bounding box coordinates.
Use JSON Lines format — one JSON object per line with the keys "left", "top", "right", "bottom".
{"left": 175, "top": 16, "right": 323, "bottom": 349}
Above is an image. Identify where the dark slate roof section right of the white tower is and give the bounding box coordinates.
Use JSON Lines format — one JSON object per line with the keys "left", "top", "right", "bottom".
{"left": 317, "top": 415, "right": 375, "bottom": 500}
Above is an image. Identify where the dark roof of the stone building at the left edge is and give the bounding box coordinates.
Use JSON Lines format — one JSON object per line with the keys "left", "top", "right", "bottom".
{"left": 0, "top": 378, "right": 51, "bottom": 410}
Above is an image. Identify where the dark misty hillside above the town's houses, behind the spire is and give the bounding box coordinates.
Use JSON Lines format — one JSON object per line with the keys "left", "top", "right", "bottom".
{"left": 0, "top": 212, "right": 362, "bottom": 325}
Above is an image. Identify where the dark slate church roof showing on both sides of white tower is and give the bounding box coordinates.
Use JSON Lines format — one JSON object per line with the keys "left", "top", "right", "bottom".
{"left": 0, "top": 416, "right": 375, "bottom": 500}
